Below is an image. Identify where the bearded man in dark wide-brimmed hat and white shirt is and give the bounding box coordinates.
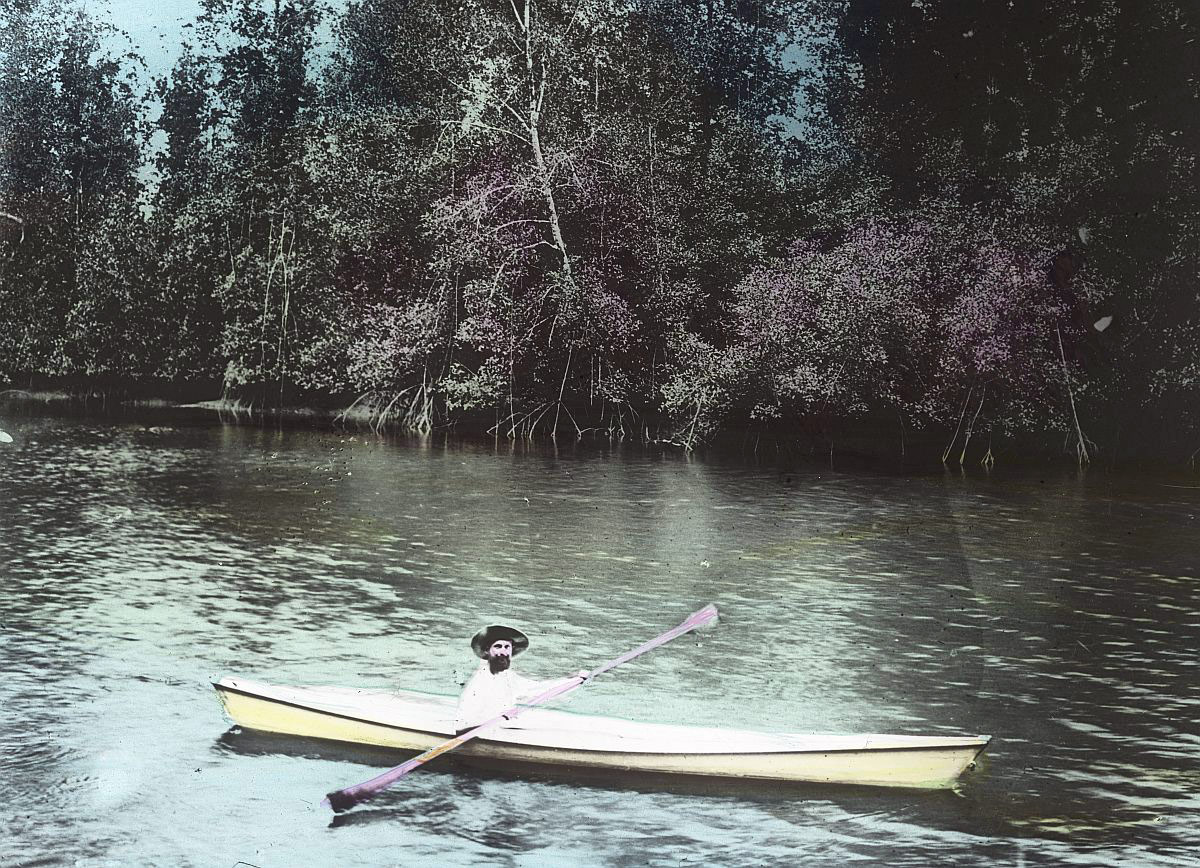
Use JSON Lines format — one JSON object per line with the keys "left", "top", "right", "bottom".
{"left": 455, "top": 624, "right": 588, "bottom": 735}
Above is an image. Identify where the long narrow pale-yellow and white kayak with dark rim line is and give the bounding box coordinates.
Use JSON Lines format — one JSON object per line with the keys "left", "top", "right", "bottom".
{"left": 212, "top": 677, "right": 991, "bottom": 789}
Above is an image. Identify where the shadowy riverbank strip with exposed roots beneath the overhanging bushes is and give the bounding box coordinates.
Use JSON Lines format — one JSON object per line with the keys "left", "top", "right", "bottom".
{"left": 0, "top": 378, "right": 1196, "bottom": 473}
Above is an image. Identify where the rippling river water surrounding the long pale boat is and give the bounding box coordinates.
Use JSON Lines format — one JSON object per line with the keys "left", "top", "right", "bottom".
{"left": 0, "top": 413, "right": 1200, "bottom": 868}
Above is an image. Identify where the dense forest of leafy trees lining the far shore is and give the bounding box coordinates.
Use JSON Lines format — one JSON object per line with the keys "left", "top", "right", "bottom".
{"left": 0, "top": 0, "right": 1200, "bottom": 465}
